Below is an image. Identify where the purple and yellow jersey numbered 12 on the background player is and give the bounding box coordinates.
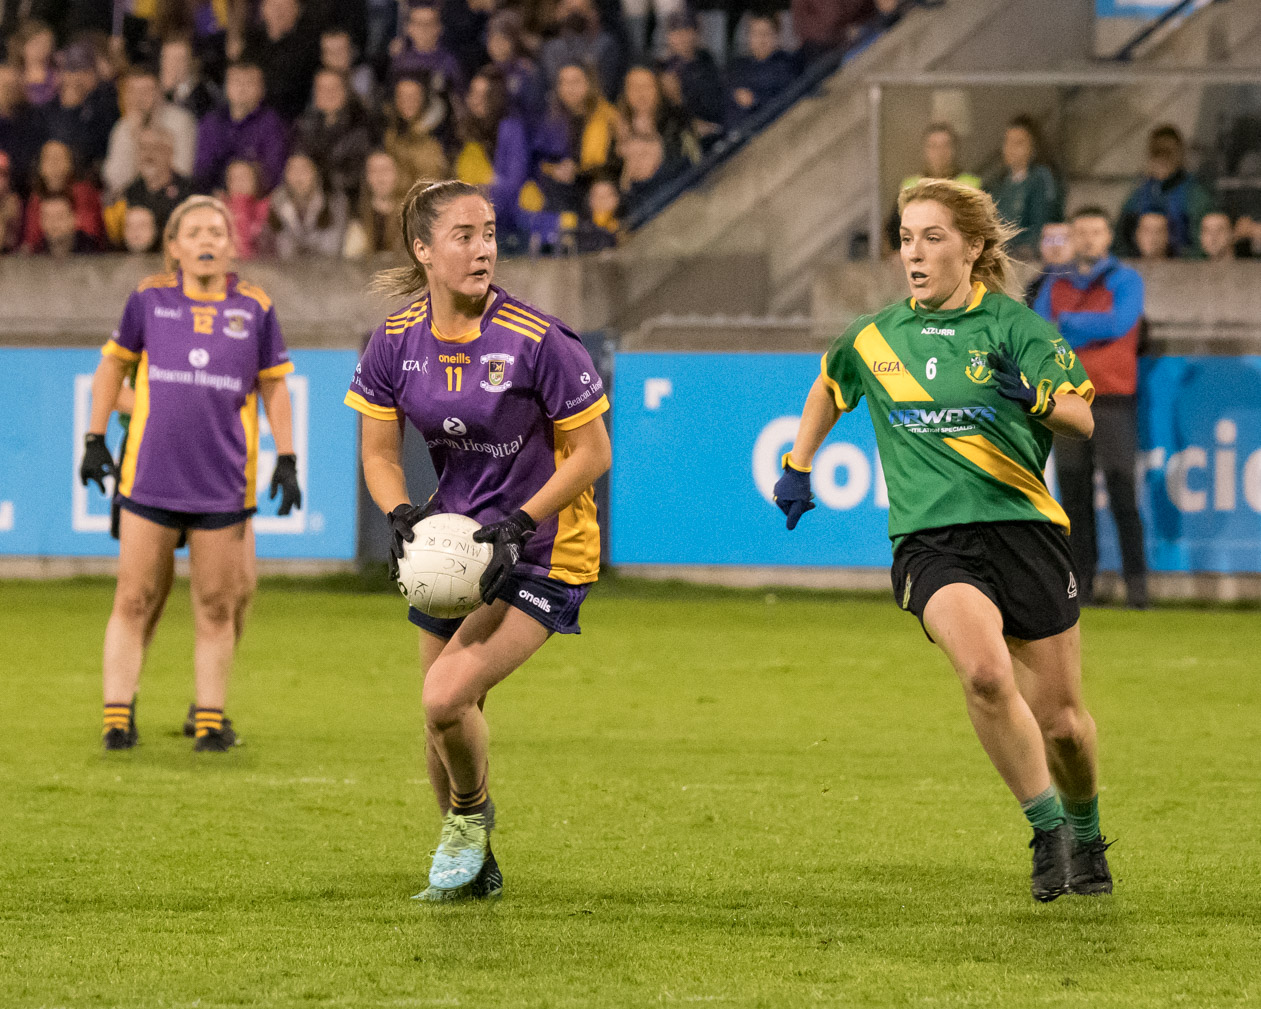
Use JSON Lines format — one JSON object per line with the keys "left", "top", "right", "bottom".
{"left": 101, "top": 272, "right": 294, "bottom": 512}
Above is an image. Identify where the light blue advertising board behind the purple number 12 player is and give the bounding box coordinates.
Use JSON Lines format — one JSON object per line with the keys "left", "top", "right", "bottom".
{"left": 0, "top": 348, "right": 358, "bottom": 560}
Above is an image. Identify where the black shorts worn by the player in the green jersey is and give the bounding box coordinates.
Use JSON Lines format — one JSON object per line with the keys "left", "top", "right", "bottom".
{"left": 890, "top": 522, "right": 1081, "bottom": 641}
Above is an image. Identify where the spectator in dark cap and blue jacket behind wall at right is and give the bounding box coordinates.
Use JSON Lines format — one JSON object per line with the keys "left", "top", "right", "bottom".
{"left": 1113, "top": 125, "right": 1213, "bottom": 256}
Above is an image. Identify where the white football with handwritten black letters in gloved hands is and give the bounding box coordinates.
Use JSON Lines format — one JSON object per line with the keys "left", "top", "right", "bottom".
{"left": 398, "top": 515, "right": 491, "bottom": 619}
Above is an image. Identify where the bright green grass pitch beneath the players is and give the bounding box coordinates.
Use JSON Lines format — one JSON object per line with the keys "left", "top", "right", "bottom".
{"left": 0, "top": 581, "right": 1261, "bottom": 1009}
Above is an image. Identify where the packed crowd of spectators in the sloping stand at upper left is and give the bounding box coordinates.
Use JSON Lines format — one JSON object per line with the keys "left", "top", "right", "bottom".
{"left": 0, "top": 0, "right": 899, "bottom": 259}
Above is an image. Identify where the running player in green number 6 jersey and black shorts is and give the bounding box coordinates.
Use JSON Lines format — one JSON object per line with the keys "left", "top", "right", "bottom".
{"left": 776, "top": 179, "right": 1112, "bottom": 901}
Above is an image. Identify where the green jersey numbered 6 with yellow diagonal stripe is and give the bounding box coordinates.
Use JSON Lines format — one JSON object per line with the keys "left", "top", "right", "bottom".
{"left": 822, "top": 284, "right": 1095, "bottom": 544}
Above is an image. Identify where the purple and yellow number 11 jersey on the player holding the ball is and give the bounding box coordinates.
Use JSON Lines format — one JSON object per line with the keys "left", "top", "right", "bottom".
{"left": 346, "top": 286, "right": 609, "bottom": 585}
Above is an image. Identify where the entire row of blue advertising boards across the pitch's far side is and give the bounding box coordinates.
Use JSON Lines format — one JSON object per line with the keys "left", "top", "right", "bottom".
{"left": 0, "top": 343, "right": 1261, "bottom": 574}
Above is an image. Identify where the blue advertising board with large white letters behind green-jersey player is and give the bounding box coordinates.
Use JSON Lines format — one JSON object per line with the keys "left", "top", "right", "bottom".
{"left": 610, "top": 353, "right": 1261, "bottom": 571}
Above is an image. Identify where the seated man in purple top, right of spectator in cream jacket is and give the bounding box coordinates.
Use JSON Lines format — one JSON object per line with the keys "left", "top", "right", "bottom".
{"left": 193, "top": 63, "right": 289, "bottom": 192}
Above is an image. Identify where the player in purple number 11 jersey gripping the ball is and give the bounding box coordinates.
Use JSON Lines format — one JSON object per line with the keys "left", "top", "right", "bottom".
{"left": 346, "top": 182, "right": 612, "bottom": 901}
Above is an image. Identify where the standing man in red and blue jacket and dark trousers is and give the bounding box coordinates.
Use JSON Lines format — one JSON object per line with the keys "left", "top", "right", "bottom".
{"left": 1034, "top": 207, "right": 1148, "bottom": 609}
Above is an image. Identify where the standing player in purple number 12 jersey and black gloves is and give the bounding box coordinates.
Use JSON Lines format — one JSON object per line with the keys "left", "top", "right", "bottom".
{"left": 79, "top": 197, "right": 301, "bottom": 752}
